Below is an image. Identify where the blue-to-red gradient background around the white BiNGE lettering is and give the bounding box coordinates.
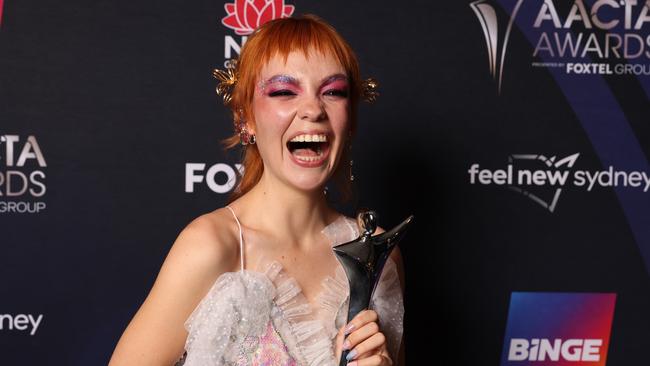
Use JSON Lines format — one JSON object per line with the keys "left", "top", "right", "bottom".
{"left": 501, "top": 292, "right": 616, "bottom": 366}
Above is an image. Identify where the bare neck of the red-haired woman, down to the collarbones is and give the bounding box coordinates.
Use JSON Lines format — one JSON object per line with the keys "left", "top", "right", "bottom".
{"left": 235, "top": 171, "right": 336, "bottom": 245}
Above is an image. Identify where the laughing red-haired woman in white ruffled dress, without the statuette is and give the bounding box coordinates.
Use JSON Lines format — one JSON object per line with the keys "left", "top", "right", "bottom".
{"left": 110, "top": 15, "right": 403, "bottom": 366}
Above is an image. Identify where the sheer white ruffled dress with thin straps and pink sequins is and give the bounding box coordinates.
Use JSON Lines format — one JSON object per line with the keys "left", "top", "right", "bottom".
{"left": 177, "top": 206, "right": 404, "bottom": 366}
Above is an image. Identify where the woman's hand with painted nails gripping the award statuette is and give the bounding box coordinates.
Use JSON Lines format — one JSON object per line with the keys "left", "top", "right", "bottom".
{"left": 335, "top": 310, "right": 393, "bottom": 366}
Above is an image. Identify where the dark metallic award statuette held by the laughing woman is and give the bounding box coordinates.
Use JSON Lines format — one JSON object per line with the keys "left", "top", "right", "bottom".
{"left": 334, "top": 211, "right": 413, "bottom": 366}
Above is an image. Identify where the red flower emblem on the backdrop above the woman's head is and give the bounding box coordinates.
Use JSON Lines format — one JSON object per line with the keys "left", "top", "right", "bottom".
{"left": 221, "top": 0, "right": 295, "bottom": 35}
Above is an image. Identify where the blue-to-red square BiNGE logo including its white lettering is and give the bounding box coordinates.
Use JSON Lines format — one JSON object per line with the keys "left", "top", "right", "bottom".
{"left": 501, "top": 292, "right": 616, "bottom": 366}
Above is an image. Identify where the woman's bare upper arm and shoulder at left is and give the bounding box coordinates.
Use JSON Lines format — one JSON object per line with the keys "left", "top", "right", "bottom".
{"left": 109, "top": 212, "right": 239, "bottom": 366}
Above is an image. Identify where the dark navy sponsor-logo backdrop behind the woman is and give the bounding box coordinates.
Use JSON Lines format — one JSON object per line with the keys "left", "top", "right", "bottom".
{"left": 0, "top": 0, "right": 650, "bottom": 366}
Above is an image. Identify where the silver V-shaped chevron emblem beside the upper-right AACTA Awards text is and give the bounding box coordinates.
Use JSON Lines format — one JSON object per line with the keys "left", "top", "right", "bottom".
{"left": 470, "top": 0, "right": 524, "bottom": 93}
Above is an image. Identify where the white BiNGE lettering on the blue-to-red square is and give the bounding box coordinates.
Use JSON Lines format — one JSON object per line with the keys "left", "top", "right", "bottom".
{"left": 508, "top": 338, "right": 603, "bottom": 362}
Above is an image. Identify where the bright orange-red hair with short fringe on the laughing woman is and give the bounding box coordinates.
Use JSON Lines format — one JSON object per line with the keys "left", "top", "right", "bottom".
{"left": 223, "top": 14, "right": 361, "bottom": 202}
